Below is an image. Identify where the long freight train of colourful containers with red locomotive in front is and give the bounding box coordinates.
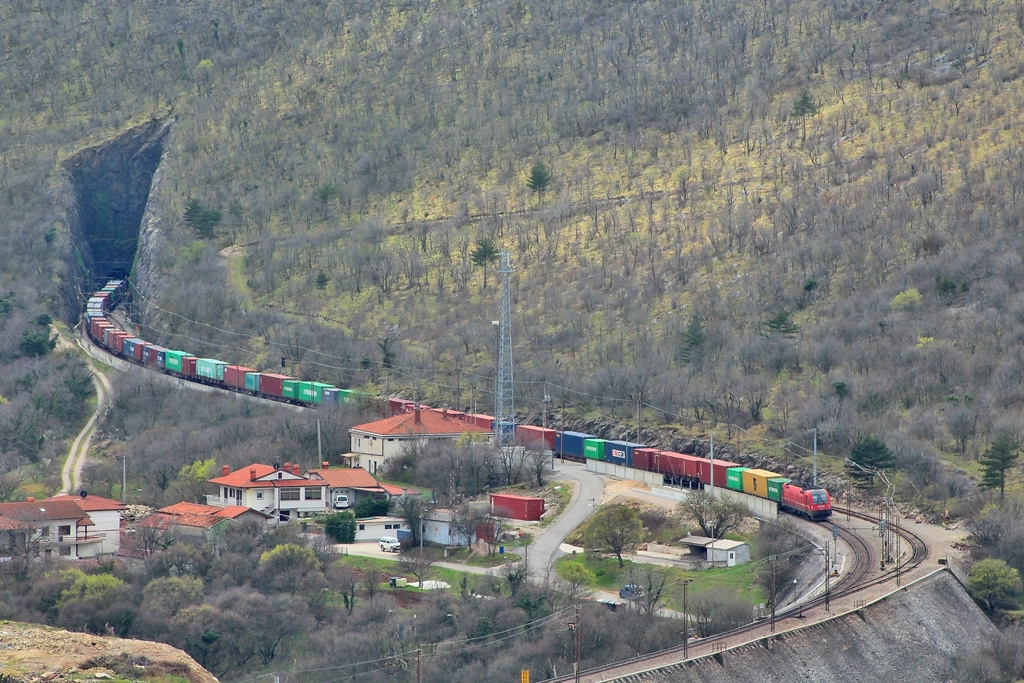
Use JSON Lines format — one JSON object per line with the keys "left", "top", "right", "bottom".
{"left": 86, "top": 280, "right": 831, "bottom": 519}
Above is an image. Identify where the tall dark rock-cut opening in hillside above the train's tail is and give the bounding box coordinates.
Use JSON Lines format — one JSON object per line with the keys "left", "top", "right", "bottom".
{"left": 67, "top": 120, "right": 170, "bottom": 286}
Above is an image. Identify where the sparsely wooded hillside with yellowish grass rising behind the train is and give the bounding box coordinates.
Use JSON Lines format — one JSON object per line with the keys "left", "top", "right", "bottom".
{"left": 6, "top": 0, "right": 1024, "bottom": 497}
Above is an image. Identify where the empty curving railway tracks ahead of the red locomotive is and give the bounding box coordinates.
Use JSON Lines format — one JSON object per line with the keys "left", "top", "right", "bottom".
{"left": 544, "top": 510, "right": 929, "bottom": 683}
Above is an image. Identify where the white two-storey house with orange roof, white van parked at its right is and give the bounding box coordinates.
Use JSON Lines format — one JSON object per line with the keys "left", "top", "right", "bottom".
{"left": 206, "top": 463, "right": 328, "bottom": 521}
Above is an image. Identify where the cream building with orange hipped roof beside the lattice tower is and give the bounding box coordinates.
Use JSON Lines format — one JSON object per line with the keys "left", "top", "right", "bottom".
{"left": 348, "top": 405, "right": 494, "bottom": 474}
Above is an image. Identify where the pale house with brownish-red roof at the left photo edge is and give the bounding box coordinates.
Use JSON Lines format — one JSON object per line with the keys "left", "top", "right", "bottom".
{"left": 0, "top": 499, "right": 104, "bottom": 559}
